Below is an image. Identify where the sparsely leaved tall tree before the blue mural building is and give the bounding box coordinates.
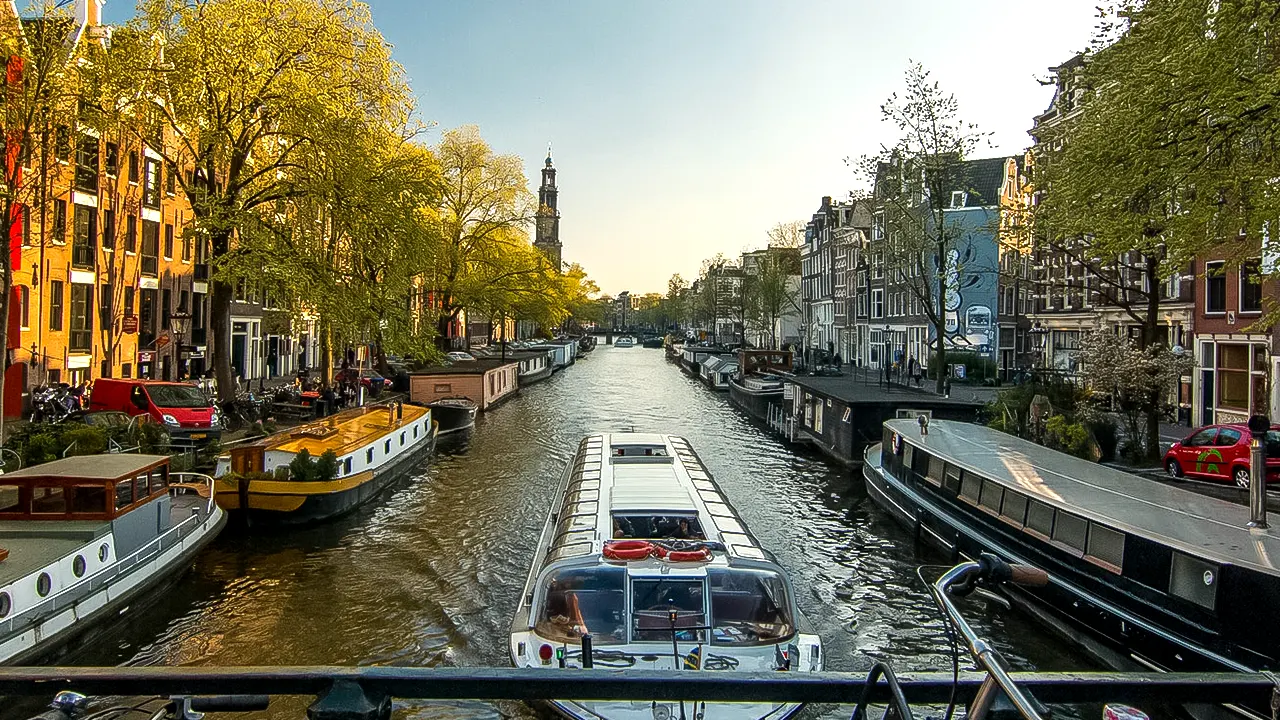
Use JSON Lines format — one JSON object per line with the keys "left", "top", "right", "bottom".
{"left": 860, "top": 64, "right": 995, "bottom": 393}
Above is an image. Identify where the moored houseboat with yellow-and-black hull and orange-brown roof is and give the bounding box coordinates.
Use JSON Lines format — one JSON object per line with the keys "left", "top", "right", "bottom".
{"left": 215, "top": 402, "right": 438, "bottom": 525}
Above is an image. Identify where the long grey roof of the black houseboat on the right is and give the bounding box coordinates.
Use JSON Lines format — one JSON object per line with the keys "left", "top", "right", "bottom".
{"left": 885, "top": 420, "right": 1280, "bottom": 573}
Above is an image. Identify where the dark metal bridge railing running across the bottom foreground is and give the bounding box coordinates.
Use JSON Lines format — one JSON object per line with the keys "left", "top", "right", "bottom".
{"left": 0, "top": 665, "right": 1275, "bottom": 720}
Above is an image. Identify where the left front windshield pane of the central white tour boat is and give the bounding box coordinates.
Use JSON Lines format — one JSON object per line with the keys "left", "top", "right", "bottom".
{"left": 534, "top": 566, "right": 627, "bottom": 644}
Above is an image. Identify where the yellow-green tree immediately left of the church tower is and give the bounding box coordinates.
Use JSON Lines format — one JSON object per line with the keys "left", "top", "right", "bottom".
{"left": 422, "top": 126, "right": 535, "bottom": 351}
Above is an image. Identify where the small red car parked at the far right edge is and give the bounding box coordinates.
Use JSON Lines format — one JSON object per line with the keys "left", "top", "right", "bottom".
{"left": 1165, "top": 424, "right": 1280, "bottom": 488}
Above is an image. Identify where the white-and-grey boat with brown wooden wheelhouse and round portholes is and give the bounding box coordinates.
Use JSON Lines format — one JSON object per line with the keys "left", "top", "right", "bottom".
{"left": 0, "top": 454, "right": 227, "bottom": 665}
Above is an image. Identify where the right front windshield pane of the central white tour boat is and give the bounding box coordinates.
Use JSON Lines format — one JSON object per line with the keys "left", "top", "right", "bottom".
{"left": 707, "top": 570, "right": 795, "bottom": 646}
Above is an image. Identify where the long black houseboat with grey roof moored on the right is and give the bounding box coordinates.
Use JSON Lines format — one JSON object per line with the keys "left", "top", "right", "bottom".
{"left": 863, "top": 418, "right": 1280, "bottom": 716}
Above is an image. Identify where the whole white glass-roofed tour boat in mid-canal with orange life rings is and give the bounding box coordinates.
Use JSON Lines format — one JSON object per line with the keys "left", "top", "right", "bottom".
{"left": 509, "top": 433, "right": 823, "bottom": 720}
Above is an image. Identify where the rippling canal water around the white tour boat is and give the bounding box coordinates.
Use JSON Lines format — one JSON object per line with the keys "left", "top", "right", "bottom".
{"left": 74, "top": 343, "right": 1088, "bottom": 719}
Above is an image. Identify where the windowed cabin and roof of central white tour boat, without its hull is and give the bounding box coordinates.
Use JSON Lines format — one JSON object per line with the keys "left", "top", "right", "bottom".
{"left": 512, "top": 433, "right": 803, "bottom": 650}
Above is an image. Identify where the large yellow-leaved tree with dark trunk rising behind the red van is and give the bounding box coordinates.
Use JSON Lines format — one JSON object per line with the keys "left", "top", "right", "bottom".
{"left": 93, "top": 0, "right": 411, "bottom": 400}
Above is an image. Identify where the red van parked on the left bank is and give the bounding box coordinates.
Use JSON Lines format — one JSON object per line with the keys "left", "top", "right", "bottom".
{"left": 88, "top": 378, "right": 223, "bottom": 445}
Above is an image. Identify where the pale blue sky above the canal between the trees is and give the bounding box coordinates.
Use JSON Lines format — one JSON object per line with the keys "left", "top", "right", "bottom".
{"left": 104, "top": 0, "right": 1096, "bottom": 295}
